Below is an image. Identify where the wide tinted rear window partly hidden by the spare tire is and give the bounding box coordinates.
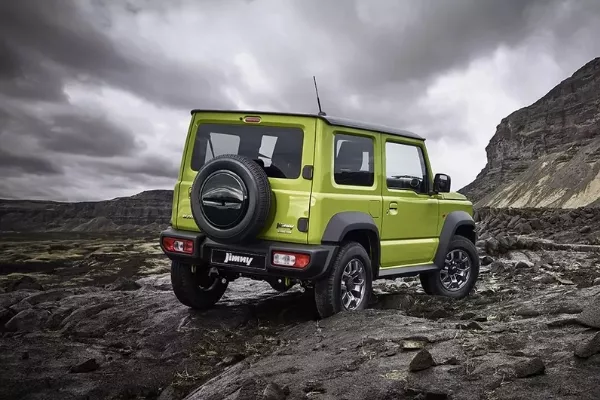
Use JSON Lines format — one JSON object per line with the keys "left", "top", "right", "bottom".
{"left": 191, "top": 124, "right": 304, "bottom": 179}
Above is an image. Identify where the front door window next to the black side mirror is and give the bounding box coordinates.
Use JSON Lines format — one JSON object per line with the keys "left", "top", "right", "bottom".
{"left": 385, "top": 142, "right": 428, "bottom": 193}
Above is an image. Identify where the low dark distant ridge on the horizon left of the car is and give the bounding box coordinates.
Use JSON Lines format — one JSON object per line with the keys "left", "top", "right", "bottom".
{"left": 0, "top": 190, "right": 173, "bottom": 232}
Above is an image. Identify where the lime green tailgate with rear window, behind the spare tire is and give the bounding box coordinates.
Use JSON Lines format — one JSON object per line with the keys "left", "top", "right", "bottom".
{"left": 178, "top": 112, "right": 316, "bottom": 243}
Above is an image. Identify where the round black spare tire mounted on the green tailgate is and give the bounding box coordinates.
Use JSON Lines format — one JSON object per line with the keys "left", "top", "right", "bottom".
{"left": 190, "top": 154, "right": 272, "bottom": 243}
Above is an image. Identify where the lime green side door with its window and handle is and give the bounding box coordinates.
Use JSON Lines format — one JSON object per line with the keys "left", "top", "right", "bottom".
{"left": 381, "top": 136, "right": 439, "bottom": 268}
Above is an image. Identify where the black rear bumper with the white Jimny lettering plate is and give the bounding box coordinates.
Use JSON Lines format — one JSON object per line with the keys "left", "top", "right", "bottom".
{"left": 160, "top": 228, "right": 338, "bottom": 280}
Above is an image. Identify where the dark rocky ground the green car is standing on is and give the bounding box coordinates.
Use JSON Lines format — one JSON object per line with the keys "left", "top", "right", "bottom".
{"left": 0, "top": 213, "right": 600, "bottom": 400}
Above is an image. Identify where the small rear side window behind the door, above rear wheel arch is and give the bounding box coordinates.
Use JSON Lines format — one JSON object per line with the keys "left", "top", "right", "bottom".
{"left": 333, "top": 134, "right": 375, "bottom": 186}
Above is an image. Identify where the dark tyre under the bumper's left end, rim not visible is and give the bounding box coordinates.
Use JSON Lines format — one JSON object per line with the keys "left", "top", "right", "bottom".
{"left": 171, "top": 261, "right": 228, "bottom": 310}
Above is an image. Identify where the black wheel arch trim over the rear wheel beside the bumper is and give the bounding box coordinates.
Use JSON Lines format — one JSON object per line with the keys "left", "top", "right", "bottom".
{"left": 321, "top": 211, "right": 381, "bottom": 279}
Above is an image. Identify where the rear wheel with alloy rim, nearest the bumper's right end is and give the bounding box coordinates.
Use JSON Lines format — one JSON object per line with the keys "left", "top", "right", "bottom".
{"left": 315, "top": 242, "right": 373, "bottom": 318}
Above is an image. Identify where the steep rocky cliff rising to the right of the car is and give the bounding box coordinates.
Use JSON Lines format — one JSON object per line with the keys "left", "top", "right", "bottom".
{"left": 460, "top": 58, "right": 600, "bottom": 208}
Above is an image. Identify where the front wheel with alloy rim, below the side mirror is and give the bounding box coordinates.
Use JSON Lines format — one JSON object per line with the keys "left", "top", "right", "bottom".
{"left": 420, "top": 236, "right": 479, "bottom": 299}
